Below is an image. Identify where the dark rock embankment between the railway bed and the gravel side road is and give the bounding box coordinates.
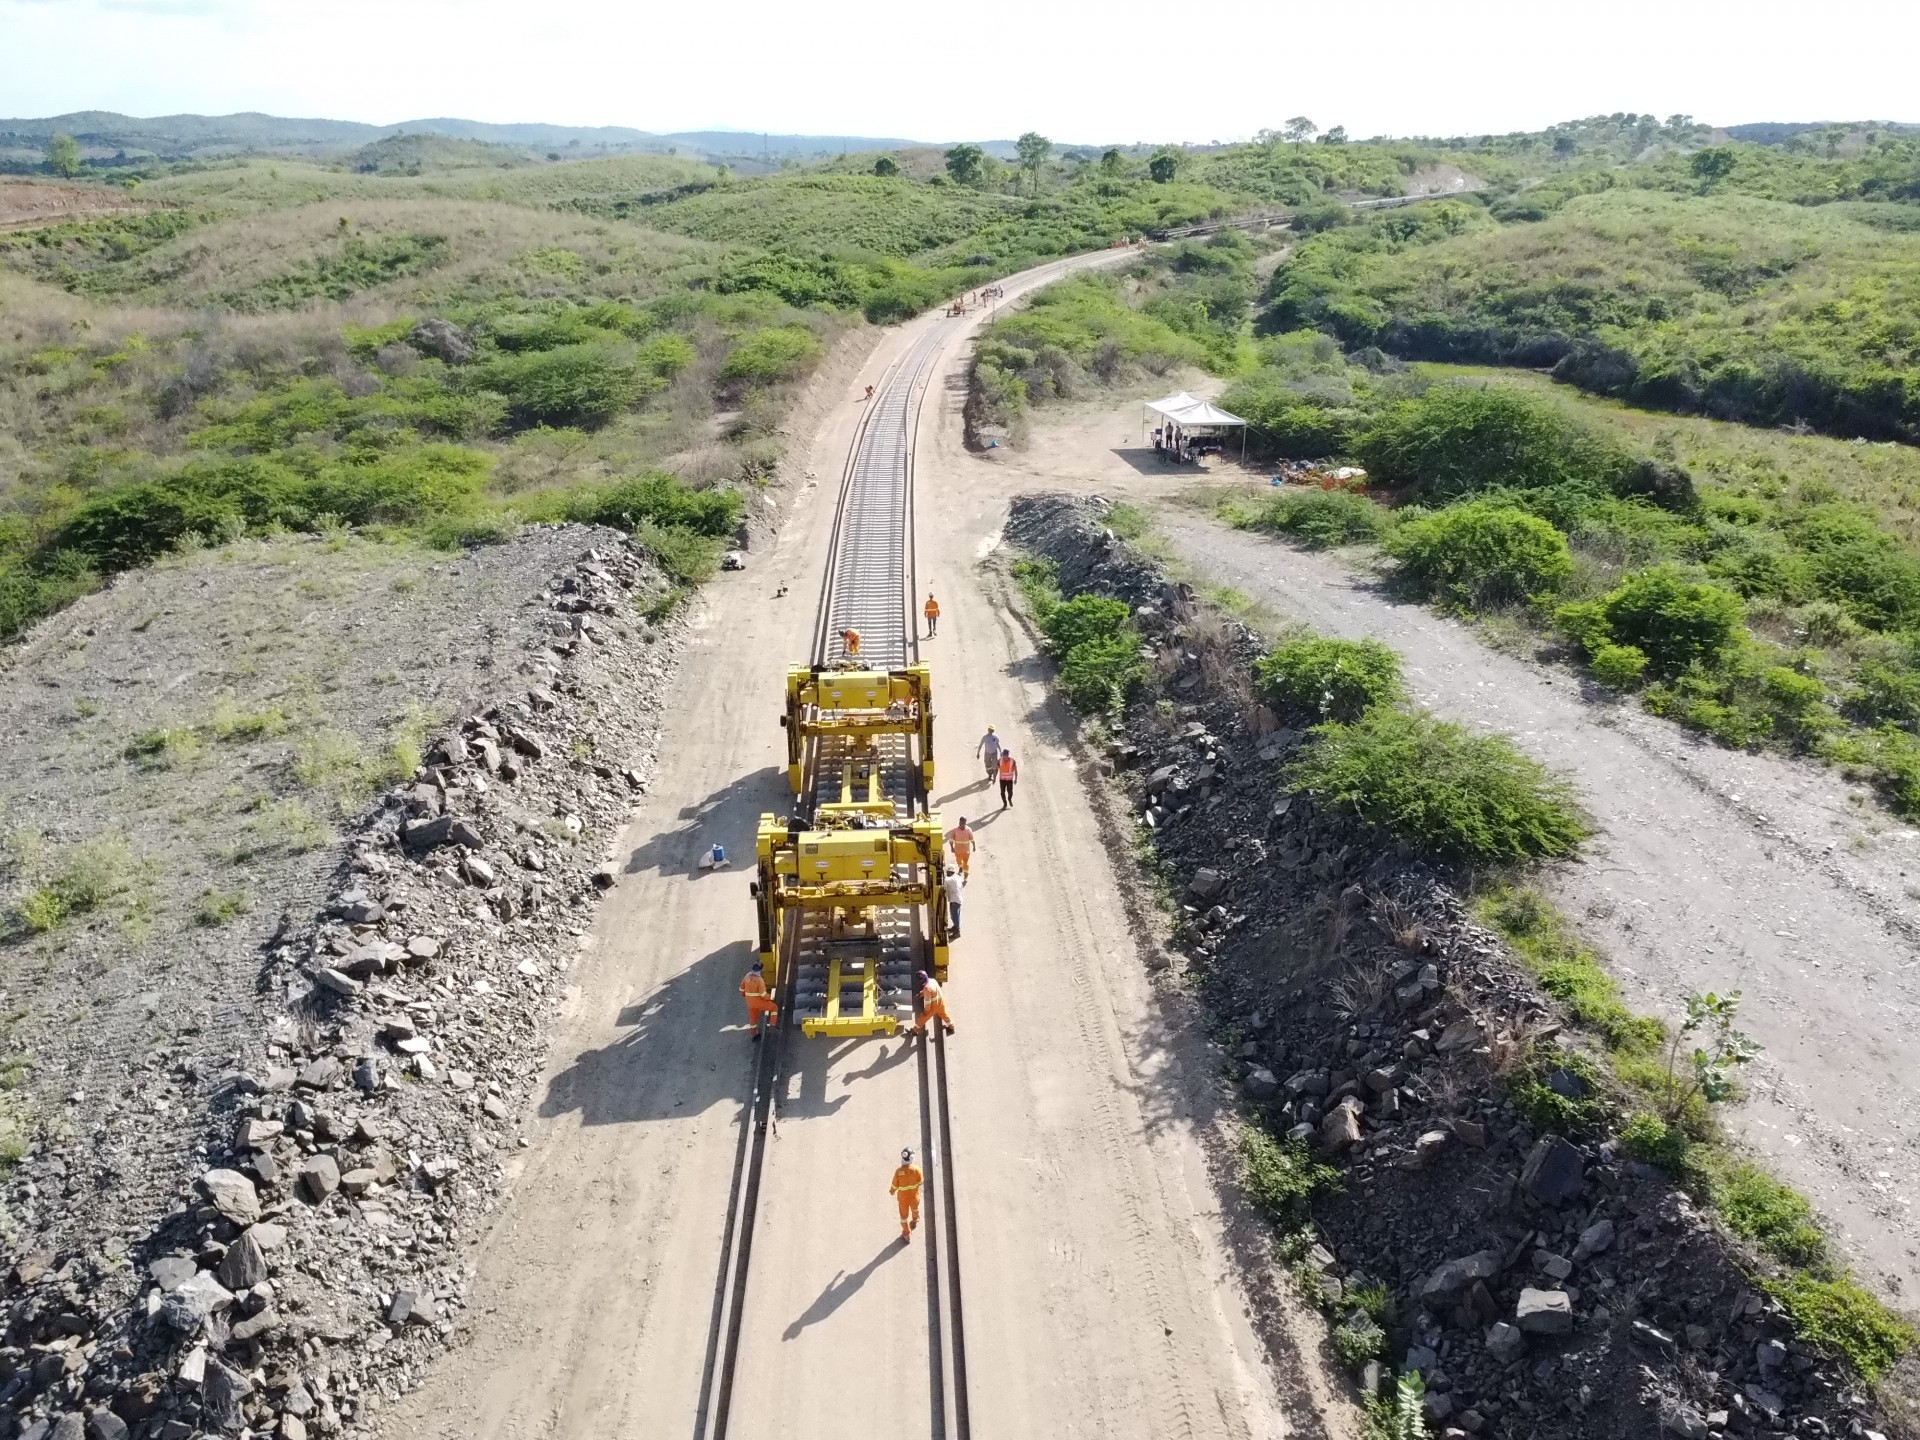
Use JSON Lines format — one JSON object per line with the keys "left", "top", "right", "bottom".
{"left": 1008, "top": 495, "right": 1884, "bottom": 1440}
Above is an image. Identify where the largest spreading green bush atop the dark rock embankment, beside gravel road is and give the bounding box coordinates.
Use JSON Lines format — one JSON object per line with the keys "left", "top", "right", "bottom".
{"left": 1286, "top": 705, "right": 1592, "bottom": 860}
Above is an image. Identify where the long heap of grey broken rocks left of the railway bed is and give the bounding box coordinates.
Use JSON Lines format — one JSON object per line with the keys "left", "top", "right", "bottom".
{"left": 0, "top": 532, "right": 676, "bottom": 1440}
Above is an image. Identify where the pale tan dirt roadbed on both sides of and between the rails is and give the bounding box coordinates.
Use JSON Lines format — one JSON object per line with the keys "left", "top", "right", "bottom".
{"left": 386, "top": 264, "right": 1327, "bottom": 1440}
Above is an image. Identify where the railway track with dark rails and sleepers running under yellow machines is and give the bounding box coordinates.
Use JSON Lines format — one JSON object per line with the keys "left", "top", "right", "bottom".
{"left": 693, "top": 323, "right": 972, "bottom": 1440}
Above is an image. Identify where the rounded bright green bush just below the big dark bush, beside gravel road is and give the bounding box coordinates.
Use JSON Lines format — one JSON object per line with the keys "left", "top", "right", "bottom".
{"left": 1386, "top": 501, "right": 1572, "bottom": 607}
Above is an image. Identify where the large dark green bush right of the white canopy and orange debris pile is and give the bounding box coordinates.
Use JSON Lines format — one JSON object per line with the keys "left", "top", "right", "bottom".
{"left": 1356, "top": 384, "right": 1634, "bottom": 499}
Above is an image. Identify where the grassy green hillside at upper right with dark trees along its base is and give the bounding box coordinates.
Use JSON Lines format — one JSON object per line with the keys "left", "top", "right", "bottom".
{"left": 1265, "top": 142, "right": 1920, "bottom": 442}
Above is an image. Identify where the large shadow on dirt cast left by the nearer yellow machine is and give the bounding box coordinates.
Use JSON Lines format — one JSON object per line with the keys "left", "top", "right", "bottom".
{"left": 540, "top": 939, "right": 755, "bottom": 1125}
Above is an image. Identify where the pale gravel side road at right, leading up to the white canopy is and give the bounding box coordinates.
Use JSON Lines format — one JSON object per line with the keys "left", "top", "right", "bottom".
{"left": 975, "top": 403, "right": 1920, "bottom": 1298}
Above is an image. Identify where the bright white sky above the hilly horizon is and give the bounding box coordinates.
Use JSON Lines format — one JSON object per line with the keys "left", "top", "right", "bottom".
{"left": 0, "top": 0, "right": 1920, "bottom": 142}
